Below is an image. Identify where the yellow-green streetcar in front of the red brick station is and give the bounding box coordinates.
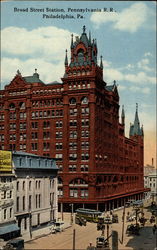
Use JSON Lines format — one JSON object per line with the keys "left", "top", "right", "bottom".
{"left": 76, "top": 208, "right": 102, "bottom": 223}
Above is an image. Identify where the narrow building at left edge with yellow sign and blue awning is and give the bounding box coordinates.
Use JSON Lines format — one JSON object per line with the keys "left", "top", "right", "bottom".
{"left": 0, "top": 150, "right": 20, "bottom": 240}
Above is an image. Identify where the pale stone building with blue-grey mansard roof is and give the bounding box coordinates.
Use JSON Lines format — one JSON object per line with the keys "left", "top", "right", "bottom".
{"left": 13, "top": 152, "right": 58, "bottom": 236}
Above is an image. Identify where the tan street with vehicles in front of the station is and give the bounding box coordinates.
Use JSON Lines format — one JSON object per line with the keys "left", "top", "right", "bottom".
{"left": 25, "top": 203, "right": 157, "bottom": 250}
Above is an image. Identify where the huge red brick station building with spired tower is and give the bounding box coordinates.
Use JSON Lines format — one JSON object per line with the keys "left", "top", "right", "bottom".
{"left": 0, "top": 27, "right": 144, "bottom": 209}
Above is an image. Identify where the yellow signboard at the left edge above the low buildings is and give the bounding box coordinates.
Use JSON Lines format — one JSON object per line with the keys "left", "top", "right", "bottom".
{"left": 0, "top": 150, "right": 12, "bottom": 172}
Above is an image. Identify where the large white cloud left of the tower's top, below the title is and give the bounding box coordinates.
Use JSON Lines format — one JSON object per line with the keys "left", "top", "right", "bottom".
{"left": 1, "top": 26, "right": 76, "bottom": 61}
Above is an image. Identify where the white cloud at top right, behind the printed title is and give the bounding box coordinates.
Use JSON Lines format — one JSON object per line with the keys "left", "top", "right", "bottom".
{"left": 91, "top": 2, "right": 149, "bottom": 33}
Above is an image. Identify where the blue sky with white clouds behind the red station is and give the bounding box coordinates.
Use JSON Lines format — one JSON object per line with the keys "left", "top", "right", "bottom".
{"left": 1, "top": 1, "right": 156, "bottom": 167}
